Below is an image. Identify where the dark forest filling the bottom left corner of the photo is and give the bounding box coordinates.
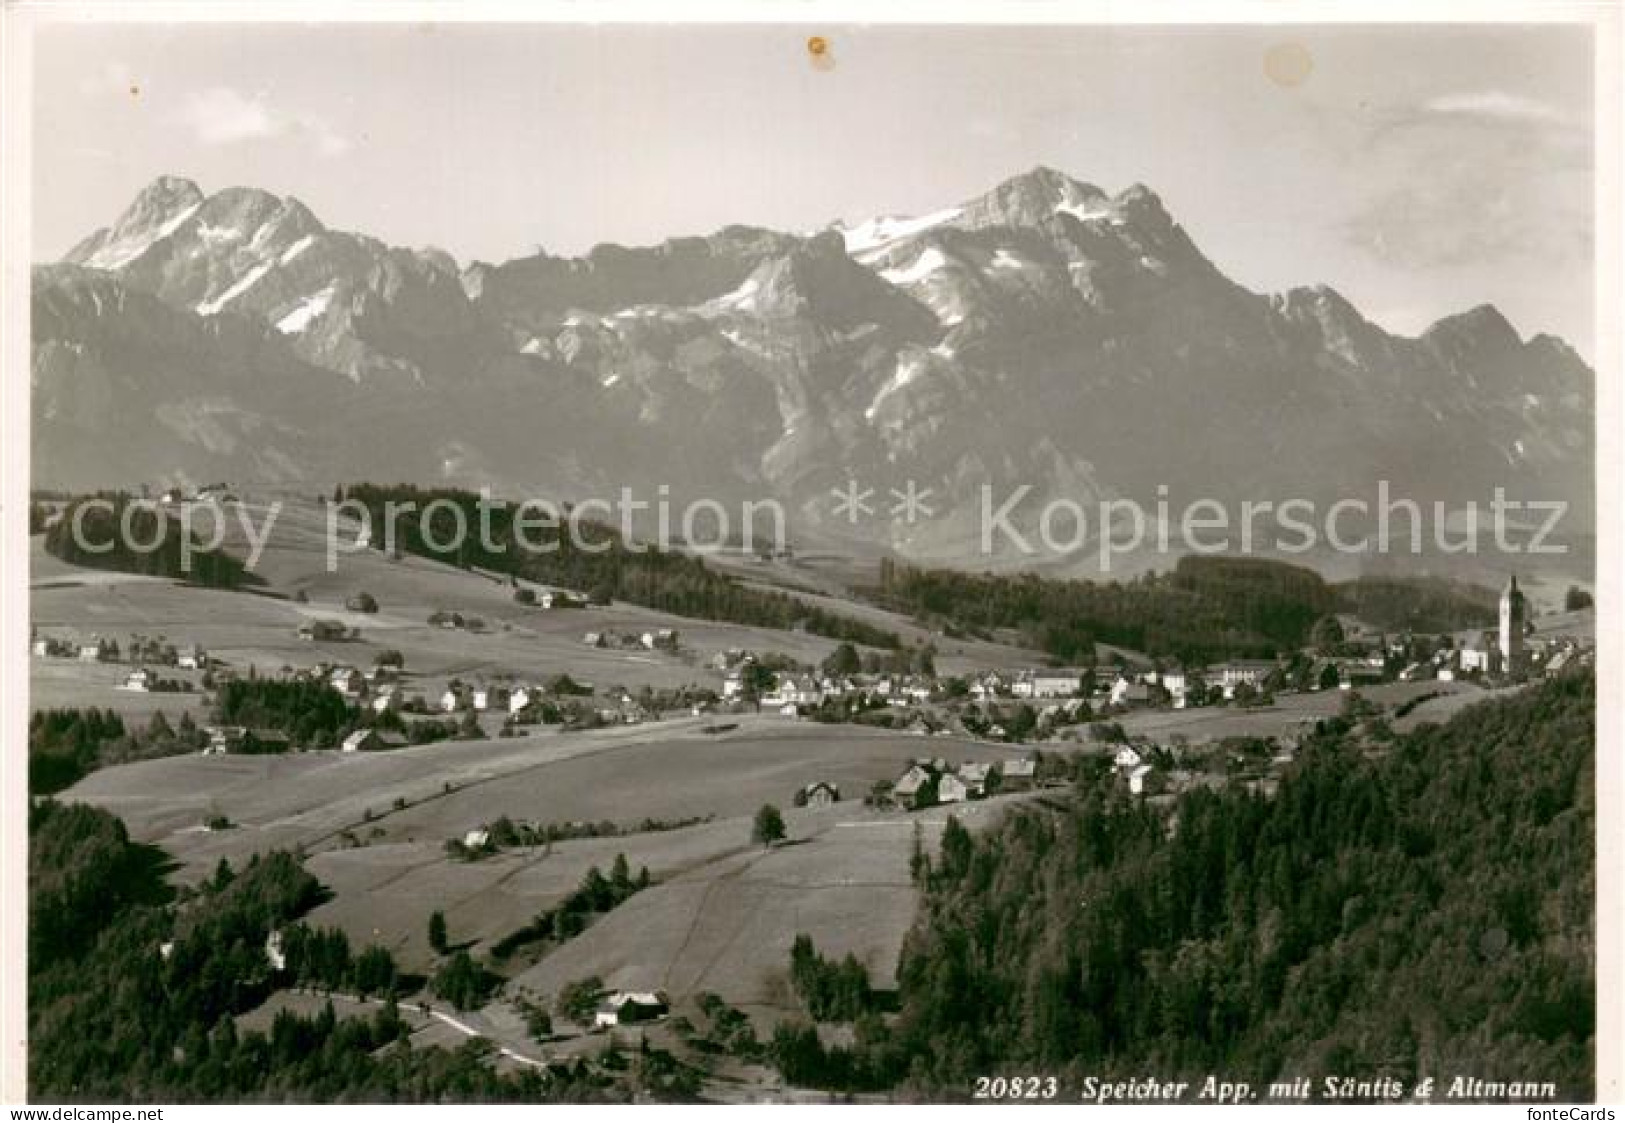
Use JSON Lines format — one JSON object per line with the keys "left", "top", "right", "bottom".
{"left": 28, "top": 800, "right": 653, "bottom": 1103}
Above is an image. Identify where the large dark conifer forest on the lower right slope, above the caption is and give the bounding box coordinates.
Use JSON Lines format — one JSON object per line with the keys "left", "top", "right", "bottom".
{"left": 772, "top": 674, "right": 1596, "bottom": 1100}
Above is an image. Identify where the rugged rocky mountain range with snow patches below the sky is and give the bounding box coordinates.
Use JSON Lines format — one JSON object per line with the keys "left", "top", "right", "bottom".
{"left": 33, "top": 167, "right": 1594, "bottom": 561}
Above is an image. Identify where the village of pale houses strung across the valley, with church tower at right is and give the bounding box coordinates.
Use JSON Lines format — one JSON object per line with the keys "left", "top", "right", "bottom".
{"left": 33, "top": 562, "right": 1593, "bottom": 825}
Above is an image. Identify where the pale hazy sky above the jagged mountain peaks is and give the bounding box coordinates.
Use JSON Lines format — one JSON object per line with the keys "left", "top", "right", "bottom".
{"left": 33, "top": 24, "right": 1594, "bottom": 358}
